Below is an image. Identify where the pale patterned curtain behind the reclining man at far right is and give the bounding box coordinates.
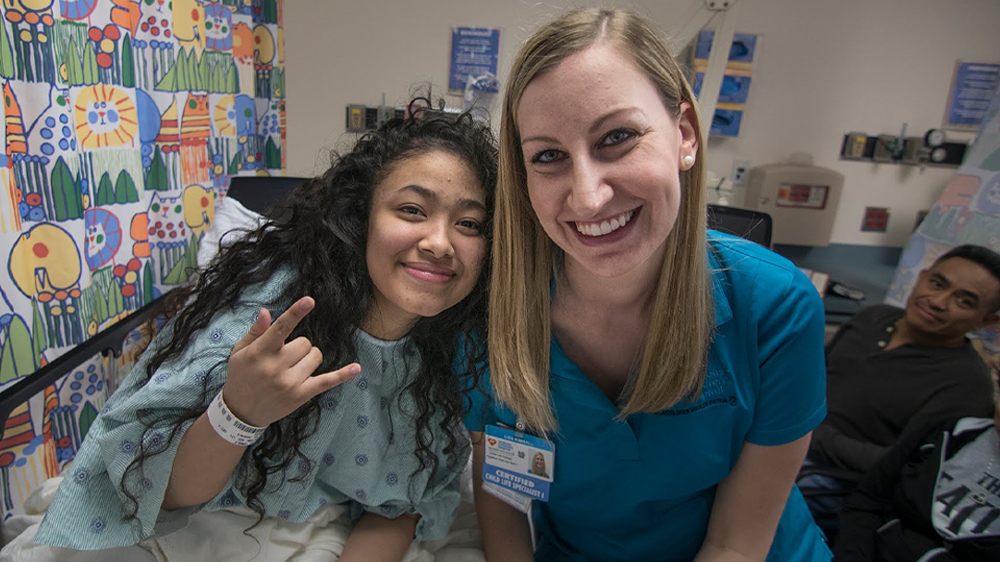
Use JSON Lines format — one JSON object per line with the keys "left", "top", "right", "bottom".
{"left": 886, "top": 91, "right": 1000, "bottom": 382}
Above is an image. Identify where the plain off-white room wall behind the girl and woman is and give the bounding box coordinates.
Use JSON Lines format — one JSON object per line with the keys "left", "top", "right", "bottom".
{"left": 284, "top": 0, "right": 1000, "bottom": 246}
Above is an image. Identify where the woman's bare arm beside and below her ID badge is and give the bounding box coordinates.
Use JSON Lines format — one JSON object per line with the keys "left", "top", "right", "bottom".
{"left": 470, "top": 431, "right": 535, "bottom": 562}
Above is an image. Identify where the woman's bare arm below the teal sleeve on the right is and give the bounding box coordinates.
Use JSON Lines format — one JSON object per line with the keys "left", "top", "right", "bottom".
{"left": 695, "top": 434, "right": 810, "bottom": 562}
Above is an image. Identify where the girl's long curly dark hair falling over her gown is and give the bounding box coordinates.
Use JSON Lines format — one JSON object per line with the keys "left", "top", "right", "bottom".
{"left": 121, "top": 104, "right": 497, "bottom": 525}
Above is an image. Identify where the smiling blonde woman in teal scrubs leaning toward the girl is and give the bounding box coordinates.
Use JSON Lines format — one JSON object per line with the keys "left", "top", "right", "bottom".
{"left": 466, "top": 9, "right": 831, "bottom": 562}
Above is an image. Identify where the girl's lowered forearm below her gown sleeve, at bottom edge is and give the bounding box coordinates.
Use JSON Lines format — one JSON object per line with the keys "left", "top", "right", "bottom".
{"left": 340, "top": 512, "right": 420, "bottom": 562}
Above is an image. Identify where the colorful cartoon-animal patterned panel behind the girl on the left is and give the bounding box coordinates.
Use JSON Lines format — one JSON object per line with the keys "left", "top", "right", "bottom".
{"left": 0, "top": 0, "right": 285, "bottom": 517}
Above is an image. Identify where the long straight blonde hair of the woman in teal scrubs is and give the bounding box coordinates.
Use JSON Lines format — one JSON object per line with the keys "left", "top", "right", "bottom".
{"left": 489, "top": 9, "right": 715, "bottom": 432}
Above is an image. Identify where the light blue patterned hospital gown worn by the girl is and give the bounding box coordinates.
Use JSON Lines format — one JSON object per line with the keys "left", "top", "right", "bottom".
{"left": 35, "top": 272, "right": 464, "bottom": 550}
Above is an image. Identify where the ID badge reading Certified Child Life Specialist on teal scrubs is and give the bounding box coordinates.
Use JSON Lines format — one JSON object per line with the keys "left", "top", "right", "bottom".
{"left": 483, "top": 425, "right": 556, "bottom": 500}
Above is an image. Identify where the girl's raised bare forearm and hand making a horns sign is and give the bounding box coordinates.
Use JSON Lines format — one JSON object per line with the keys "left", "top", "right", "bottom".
{"left": 162, "top": 297, "right": 361, "bottom": 510}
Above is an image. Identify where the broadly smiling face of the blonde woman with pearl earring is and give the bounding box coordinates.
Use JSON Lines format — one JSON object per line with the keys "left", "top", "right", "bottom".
{"left": 517, "top": 44, "right": 697, "bottom": 277}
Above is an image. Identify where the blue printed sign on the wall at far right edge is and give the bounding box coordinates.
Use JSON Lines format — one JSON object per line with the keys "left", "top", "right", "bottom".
{"left": 943, "top": 62, "right": 1000, "bottom": 132}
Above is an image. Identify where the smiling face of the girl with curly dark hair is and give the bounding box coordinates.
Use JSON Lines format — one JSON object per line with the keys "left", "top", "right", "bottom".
{"left": 363, "top": 150, "right": 487, "bottom": 339}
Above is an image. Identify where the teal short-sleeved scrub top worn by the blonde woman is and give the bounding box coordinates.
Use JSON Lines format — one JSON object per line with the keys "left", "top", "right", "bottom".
{"left": 465, "top": 232, "right": 832, "bottom": 562}
